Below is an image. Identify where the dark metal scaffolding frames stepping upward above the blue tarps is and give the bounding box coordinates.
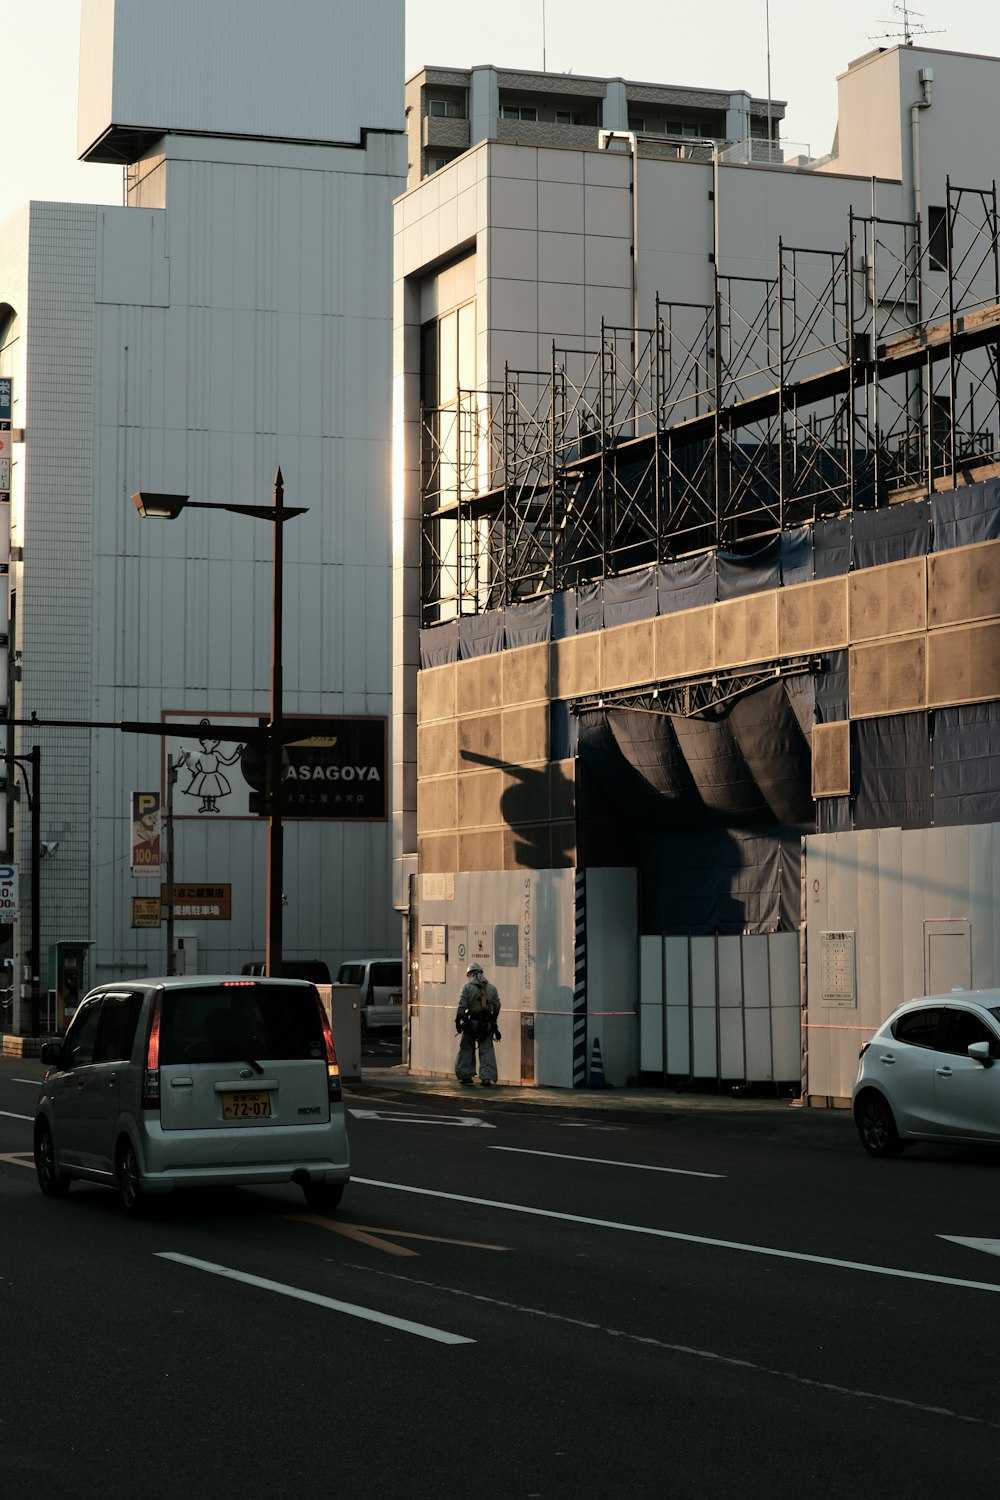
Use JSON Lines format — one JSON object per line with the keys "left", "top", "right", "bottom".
{"left": 420, "top": 179, "right": 1000, "bottom": 624}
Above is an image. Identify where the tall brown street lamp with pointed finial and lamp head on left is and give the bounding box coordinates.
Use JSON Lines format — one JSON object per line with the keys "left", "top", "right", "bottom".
{"left": 132, "top": 468, "right": 307, "bottom": 978}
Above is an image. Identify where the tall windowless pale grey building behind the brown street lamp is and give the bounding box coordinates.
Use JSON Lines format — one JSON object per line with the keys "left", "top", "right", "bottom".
{"left": 0, "top": 0, "right": 406, "bottom": 1026}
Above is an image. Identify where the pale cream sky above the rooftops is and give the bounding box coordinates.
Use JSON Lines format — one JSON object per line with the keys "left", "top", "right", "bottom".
{"left": 7, "top": 0, "right": 1000, "bottom": 221}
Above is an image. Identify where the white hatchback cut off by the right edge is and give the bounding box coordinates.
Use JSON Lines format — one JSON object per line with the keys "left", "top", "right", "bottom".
{"left": 853, "top": 990, "right": 1000, "bottom": 1157}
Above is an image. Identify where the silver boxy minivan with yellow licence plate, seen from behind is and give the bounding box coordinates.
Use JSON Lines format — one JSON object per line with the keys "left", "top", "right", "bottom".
{"left": 34, "top": 975, "right": 351, "bottom": 1215}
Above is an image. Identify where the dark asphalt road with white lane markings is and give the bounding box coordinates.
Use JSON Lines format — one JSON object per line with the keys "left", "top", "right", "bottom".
{"left": 0, "top": 1059, "right": 1000, "bottom": 1500}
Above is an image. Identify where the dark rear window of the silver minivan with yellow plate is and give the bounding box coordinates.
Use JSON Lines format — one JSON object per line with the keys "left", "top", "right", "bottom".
{"left": 160, "top": 980, "right": 325, "bottom": 1067}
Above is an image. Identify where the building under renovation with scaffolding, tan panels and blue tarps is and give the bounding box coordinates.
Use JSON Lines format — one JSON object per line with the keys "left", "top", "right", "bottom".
{"left": 393, "top": 47, "right": 1000, "bottom": 1100}
